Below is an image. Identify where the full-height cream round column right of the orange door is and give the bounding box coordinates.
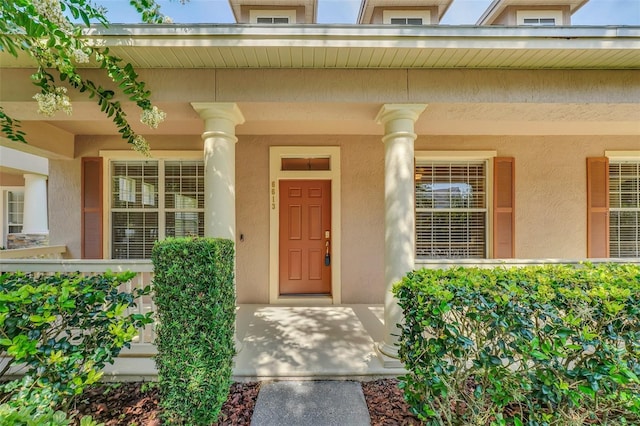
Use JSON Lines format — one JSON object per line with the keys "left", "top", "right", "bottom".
{"left": 376, "top": 104, "right": 426, "bottom": 366}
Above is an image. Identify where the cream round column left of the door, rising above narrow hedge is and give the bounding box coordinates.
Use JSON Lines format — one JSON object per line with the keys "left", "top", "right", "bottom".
{"left": 191, "top": 102, "right": 244, "bottom": 238}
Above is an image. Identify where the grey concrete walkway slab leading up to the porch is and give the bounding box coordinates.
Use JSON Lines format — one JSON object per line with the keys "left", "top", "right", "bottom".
{"left": 251, "top": 381, "right": 371, "bottom": 426}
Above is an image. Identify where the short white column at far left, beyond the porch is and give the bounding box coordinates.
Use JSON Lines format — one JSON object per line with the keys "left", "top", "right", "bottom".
{"left": 22, "top": 173, "right": 49, "bottom": 234}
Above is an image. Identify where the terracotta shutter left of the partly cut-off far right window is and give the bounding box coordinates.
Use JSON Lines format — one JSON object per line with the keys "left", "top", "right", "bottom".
{"left": 587, "top": 157, "right": 609, "bottom": 258}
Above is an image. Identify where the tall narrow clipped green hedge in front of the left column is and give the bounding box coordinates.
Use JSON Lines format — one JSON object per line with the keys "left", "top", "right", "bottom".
{"left": 152, "top": 238, "right": 235, "bottom": 425}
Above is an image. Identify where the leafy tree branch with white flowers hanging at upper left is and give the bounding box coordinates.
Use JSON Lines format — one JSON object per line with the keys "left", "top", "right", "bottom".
{"left": 0, "top": 0, "right": 188, "bottom": 155}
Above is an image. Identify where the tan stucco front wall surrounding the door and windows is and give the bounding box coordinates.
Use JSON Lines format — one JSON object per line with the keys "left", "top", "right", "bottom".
{"left": 49, "top": 135, "right": 638, "bottom": 303}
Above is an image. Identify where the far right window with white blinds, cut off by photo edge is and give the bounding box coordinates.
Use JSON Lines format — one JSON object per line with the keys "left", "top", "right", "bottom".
{"left": 609, "top": 161, "right": 640, "bottom": 257}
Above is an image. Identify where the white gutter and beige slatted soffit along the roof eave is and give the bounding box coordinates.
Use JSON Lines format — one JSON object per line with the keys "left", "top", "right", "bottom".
{"left": 0, "top": 24, "right": 640, "bottom": 69}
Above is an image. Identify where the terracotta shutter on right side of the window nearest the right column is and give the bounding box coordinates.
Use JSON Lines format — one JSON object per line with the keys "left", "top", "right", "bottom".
{"left": 493, "top": 157, "right": 515, "bottom": 259}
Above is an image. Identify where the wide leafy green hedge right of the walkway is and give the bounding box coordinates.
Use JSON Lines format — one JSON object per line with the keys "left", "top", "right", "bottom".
{"left": 394, "top": 264, "right": 640, "bottom": 425}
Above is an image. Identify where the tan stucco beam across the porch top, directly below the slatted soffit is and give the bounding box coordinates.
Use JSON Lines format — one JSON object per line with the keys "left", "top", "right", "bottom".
{"left": 0, "top": 69, "right": 640, "bottom": 105}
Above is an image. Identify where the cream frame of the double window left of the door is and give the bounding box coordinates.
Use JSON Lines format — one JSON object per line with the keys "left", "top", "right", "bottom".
{"left": 99, "top": 151, "right": 206, "bottom": 260}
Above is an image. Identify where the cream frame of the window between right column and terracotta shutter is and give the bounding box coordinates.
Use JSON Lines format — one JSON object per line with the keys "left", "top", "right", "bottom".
{"left": 414, "top": 151, "right": 497, "bottom": 263}
